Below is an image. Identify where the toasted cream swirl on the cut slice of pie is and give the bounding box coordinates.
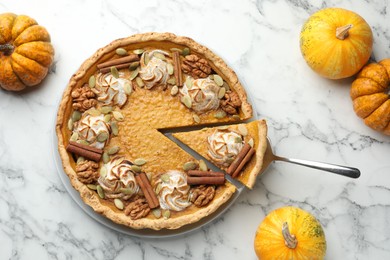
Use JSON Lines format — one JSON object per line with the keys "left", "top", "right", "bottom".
{"left": 207, "top": 130, "right": 244, "bottom": 167}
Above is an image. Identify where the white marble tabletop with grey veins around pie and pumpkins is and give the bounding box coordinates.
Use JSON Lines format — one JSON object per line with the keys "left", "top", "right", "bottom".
{"left": 0, "top": 0, "right": 390, "bottom": 259}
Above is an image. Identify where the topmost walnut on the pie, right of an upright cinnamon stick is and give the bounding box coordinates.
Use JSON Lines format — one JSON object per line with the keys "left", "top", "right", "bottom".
{"left": 181, "top": 54, "right": 211, "bottom": 79}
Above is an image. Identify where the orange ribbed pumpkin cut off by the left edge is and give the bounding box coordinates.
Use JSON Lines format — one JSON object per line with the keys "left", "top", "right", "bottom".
{"left": 0, "top": 13, "right": 54, "bottom": 91}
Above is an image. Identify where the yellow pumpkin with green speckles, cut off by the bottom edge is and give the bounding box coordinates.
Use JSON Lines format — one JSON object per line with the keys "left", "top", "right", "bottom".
{"left": 254, "top": 206, "right": 326, "bottom": 260}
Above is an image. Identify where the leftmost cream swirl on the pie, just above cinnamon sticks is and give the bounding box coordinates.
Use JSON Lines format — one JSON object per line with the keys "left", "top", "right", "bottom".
{"left": 73, "top": 113, "right": 111, "bottom": 149}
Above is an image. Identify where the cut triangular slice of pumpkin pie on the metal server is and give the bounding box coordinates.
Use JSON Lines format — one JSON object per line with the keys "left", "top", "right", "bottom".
{"left": 173, "top": 120, "right": 267, "bottom": 189}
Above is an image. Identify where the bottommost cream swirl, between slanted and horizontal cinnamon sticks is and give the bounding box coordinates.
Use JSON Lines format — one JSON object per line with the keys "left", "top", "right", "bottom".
{"left": 156, "top": 170, "right": 191, "bottom": 211}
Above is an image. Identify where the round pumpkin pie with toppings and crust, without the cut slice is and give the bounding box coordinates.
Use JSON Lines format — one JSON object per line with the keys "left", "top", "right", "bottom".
{"left": 56, "top": 33, "right": 252, "bottom": 230}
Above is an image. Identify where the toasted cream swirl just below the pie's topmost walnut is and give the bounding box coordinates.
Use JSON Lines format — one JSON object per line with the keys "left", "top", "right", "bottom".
{"left": 180, "top": 78, "right": 220, "bottom": 114}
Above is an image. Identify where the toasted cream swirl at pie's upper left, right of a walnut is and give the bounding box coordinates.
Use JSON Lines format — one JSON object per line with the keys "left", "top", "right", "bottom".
{"left": 92, "top": 73, "right": 131, "bottom": 107}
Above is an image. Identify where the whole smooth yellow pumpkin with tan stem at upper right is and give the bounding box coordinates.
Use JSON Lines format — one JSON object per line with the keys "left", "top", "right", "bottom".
{"left": 300, "top": 8, "right": 373, "bottom": 79}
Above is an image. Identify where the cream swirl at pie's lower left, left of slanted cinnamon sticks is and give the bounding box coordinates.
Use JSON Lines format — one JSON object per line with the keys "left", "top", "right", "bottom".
{"left": 98, "top": 157, "right": 139, "bottom": 200}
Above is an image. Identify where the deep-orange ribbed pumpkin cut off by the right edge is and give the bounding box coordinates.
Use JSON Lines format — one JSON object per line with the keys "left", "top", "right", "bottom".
{"left": 350, "top": 59, "right": 390, "bottom": 135}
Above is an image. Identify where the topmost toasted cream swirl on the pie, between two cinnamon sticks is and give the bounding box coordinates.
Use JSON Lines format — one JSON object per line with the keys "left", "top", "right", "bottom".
{"left": 139, "top": 50, "right": 169, "bottom": 89}
